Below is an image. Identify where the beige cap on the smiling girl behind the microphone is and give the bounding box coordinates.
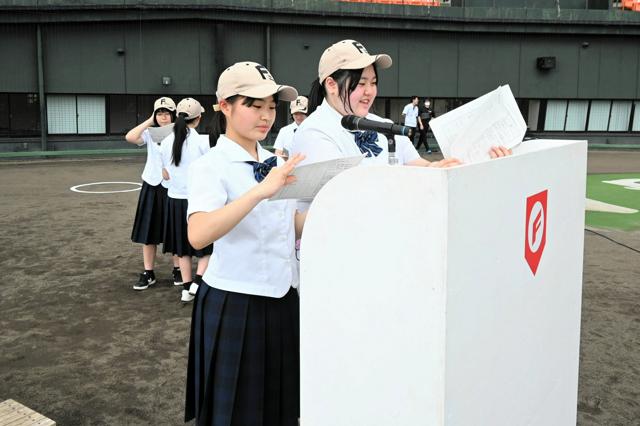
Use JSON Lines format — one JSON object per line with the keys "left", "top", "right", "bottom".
{"left": 318, "top": 40, "right": 393, "bottom": 83}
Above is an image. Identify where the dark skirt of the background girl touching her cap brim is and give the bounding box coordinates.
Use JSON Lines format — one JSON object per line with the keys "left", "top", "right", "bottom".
{"left": 131, "top": 181, "right": 167, "bottom": 244}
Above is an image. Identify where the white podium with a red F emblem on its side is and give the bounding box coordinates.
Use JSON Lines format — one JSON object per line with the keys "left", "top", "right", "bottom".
{"left": 300, "top": 140, "right": 587, "bottom": 426}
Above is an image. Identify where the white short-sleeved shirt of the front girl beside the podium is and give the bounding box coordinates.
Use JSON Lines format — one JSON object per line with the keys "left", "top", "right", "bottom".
{"left": 187, "top": 135, "right": 298, "bottom": 298}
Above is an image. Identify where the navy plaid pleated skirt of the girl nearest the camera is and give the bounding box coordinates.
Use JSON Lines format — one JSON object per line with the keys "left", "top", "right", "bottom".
{"left": 185, "top": 284, "right": 300, "bottom": 426}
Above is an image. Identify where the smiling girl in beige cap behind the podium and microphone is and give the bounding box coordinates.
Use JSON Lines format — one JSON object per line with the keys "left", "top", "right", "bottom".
{"left": 291, "top": 40, "right": 508, "bottom": 167}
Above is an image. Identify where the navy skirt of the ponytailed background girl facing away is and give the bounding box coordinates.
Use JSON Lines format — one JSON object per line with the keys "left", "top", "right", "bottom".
{"left": 162, "top": 197, "right": 213, "bottom": 257}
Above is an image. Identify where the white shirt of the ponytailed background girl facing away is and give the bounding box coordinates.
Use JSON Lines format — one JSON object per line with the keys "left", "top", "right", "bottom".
{"left": 160, "top": 128, "right": 209, "bottom": 200}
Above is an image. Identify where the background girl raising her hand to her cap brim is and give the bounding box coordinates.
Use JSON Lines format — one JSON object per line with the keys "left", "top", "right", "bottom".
{"left": 125, "top": 96, "right": 182, "bottom": 290}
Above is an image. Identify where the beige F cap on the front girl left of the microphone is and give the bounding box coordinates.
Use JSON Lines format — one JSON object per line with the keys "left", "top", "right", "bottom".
{"left": 216, "top": 62, "right": 298, "bottom": 101}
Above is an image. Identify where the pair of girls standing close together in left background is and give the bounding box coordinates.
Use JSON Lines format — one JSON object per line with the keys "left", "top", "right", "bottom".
{"left": 125, "top": 97, "right": 213, "bottom": 302}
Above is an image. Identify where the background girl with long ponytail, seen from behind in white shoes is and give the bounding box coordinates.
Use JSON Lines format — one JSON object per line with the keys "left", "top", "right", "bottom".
{"left": 160, "top": 98, "right": 213, "bottom": 302}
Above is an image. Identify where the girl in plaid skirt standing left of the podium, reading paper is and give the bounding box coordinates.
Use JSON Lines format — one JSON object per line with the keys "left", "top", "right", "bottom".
{"left": 185, "top": 62, "right": 305, "bottom": 425}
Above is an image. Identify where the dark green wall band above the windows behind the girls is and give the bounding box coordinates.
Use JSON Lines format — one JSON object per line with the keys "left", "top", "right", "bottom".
{"left": 0, "top": 21, "right": 640, "bottom": 99}
